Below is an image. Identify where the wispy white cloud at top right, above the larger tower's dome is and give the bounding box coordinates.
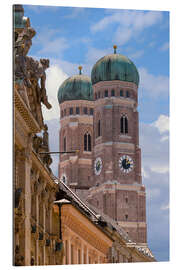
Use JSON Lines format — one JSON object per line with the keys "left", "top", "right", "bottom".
{"left": 91, "top": 10, "right": 162, "bottom": 45}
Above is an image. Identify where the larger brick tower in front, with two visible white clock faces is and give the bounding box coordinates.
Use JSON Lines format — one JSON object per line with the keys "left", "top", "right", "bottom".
{"left": 88, "top": 46, "right": 147, "bottom": 245}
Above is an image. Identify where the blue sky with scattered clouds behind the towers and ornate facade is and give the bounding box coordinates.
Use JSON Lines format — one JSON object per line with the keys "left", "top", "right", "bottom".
{"left": 24, "top": 5, "right": 169, "bottom": 261}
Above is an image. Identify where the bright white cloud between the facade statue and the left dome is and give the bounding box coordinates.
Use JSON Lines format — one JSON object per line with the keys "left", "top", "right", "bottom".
{"left": 42, "top": 65, "right": 68, "bottom": 120}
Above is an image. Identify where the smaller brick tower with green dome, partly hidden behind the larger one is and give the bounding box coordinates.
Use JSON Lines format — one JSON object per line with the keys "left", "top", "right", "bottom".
{"left": 58, "top": 66, "right": 94, "bottom": 195}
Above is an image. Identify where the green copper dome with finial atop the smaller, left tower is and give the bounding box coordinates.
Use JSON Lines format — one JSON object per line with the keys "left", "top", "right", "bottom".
{"left": 58, "top": 66, "right": 93, "bottom": 103}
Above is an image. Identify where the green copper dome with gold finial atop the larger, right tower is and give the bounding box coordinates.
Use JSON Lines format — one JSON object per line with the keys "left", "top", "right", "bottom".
{"left": 91, "top": 45, "right": 139, "bottom": 86}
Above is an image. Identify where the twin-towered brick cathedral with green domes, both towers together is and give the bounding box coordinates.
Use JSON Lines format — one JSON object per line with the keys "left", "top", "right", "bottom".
{"left": 58, "top": 46, "right": 147, "bottom": 246}
